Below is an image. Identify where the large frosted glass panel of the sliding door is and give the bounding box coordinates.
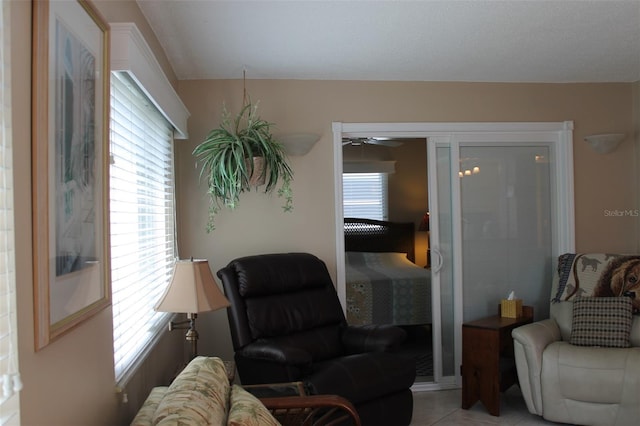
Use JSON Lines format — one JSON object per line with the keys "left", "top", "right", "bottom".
{"left": 458, "top": 142, "right": 554, "bottom": 321}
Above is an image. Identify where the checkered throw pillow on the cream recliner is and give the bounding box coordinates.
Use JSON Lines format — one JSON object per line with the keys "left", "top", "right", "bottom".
{"left": 569, "top": 297, "right": 633, "bottom": 348}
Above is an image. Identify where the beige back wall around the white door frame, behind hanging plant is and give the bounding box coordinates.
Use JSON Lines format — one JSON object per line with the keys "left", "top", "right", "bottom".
{"left": 176, "top": 80, "right": 638, "bottom": 356}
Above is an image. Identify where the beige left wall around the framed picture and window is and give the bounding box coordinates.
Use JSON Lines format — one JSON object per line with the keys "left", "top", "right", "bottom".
{"left": 11, "top": 0, "right": 184, "bottom": 426}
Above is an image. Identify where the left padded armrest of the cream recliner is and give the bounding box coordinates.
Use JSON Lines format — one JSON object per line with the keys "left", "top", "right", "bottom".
{"left": 511, "top": 319, "right": 561, "bottom": 416}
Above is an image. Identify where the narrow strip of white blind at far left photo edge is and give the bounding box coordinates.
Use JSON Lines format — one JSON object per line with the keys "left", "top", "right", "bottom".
{"left": 0, "top": 1, "right": 22, "bottom": 425}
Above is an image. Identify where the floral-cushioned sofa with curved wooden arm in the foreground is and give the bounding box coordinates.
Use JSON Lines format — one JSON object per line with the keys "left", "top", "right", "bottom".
{"left": 131, "top": 356, "right": 360, "bottom": 426}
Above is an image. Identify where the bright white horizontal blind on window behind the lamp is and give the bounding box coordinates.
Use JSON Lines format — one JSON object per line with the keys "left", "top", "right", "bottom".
{"left": 110, "top": 73, "right": 176, "bottom": 385}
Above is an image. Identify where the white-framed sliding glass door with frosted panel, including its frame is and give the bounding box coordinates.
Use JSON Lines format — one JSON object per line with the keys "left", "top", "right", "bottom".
{"left": 333, "top": 122, "right": 575, "bottom": 390}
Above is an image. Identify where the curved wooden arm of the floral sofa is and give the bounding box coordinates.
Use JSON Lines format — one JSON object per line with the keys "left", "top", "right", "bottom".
{"left": 260, "top": 395, "right": 360, "bottom": 426}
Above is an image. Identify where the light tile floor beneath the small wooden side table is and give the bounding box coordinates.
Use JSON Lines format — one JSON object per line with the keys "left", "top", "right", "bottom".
{"left": 411, "top": 386, "right": 558, "bottom": 426}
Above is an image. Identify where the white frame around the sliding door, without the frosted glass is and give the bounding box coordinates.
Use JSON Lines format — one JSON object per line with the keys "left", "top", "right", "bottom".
{"left": 332, "top": 121, "right": 575, "bottom": 391}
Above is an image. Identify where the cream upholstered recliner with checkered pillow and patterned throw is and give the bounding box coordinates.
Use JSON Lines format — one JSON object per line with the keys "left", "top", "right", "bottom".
{"left": 512, "top": 253, "right": 640, "bottom": 426}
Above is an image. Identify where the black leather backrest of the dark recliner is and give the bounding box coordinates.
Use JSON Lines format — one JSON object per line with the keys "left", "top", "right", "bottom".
{"left": 218, "top": 253, "right": 346, "bottom": 360}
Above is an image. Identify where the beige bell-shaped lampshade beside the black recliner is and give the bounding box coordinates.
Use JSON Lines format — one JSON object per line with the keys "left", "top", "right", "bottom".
{"left": 155, "top": 259, "right": 230, "bottom": 314}
